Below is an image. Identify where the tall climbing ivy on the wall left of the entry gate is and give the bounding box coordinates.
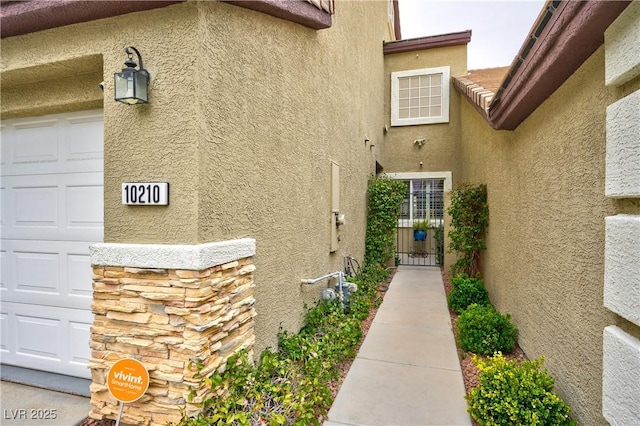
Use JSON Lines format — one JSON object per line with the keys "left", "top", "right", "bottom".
{"left": 364, "top": 177, "right": 407, "bottom": 267}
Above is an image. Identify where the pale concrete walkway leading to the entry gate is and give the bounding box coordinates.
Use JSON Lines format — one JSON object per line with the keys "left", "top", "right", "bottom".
{"left": 324, "top": 266, "right": 471, "bottom": 426}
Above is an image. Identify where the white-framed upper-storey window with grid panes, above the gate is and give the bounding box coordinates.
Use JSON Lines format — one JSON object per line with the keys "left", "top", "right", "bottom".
{"left": 391, "top": 67, "right": 450, "bottom": 126}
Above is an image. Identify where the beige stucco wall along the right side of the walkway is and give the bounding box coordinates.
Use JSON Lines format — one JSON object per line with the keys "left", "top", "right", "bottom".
{"left": 460, "top": 48, "right": 640, "bottom": 425}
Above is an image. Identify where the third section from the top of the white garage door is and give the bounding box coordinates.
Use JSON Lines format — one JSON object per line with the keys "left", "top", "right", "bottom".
{"left": 2, "top": 240, "right": 94, "bottom": 309}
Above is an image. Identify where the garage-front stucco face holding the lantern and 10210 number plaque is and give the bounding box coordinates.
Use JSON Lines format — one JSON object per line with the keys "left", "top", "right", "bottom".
{"left": 2, "top": 3, "right": 204, "bottom": 244}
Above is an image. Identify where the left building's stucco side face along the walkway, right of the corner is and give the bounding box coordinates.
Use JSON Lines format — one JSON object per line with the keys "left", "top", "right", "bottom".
{"left": 192, "top": 2, "right": 387, "bottom": 349}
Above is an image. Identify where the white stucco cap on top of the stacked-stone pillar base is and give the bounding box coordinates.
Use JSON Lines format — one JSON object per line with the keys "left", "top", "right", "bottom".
{"left": 89, "top": 238, "right": 256, "bottom": 271}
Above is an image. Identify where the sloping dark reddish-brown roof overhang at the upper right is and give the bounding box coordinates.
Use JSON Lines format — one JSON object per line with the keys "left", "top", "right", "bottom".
{"left": 484, "top": 0, "right": 631, "bottom": 130}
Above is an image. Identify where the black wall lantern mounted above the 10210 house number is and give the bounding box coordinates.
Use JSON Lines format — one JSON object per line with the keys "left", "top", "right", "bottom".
{"left": 113, "top": 46, "right": 151, "bottom": 105}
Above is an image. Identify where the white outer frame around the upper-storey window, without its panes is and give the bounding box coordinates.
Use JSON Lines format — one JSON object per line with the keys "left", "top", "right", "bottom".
{"left": 391, "top": 66, "right": 451, "bottom": 126}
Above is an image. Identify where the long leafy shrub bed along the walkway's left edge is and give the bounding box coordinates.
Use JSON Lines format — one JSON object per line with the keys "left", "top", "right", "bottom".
{"left": 174, "top": 266, "right": 389, "bottom": 426}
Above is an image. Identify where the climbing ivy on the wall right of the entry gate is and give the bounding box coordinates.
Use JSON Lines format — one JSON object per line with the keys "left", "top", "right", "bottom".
{"left": 447, "top": 183, "right": 489, "bottom": 277}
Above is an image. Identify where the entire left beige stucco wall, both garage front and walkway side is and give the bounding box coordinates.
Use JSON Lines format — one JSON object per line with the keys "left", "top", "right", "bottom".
{"left": 1, "top": 1, "right": 388, "bottom": 354}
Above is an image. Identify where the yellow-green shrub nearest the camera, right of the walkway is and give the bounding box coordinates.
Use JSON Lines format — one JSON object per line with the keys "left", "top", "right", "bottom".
{"left": 466, "top": 354, "right": 577, "bottom": 426}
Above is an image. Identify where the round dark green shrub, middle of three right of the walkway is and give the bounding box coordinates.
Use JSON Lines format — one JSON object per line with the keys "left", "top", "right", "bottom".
{"left": 458, "top": 303, "right": 518, "bottom": 355}
